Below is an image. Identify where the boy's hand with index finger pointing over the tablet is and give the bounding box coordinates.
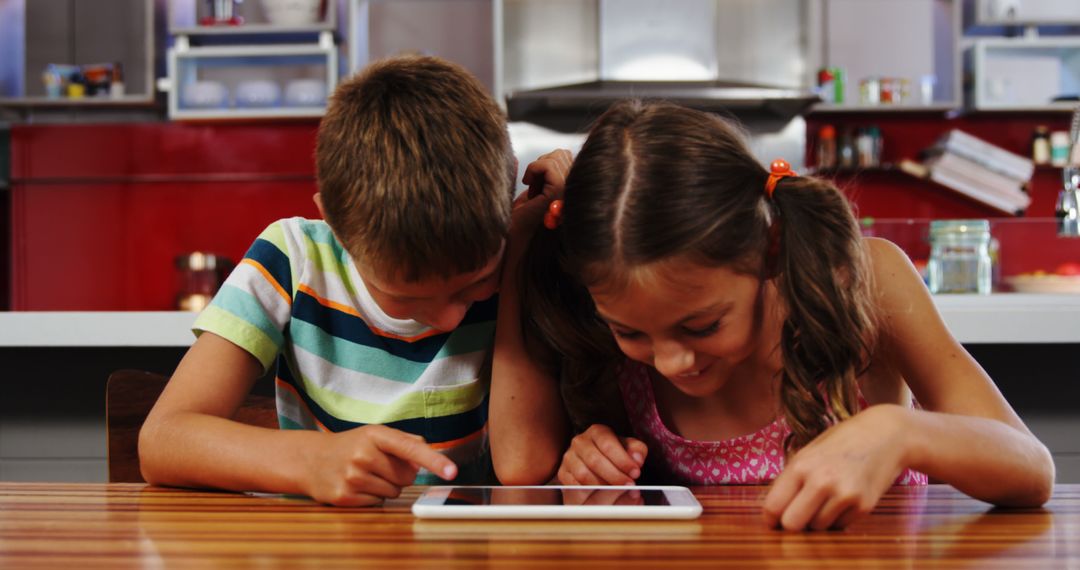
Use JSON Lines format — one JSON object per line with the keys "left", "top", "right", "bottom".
{"left": 303, "top": 425, "right": 458, "bottom": 506}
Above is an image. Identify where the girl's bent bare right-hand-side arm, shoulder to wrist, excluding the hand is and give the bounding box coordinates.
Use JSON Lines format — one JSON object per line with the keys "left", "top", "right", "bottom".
{"left": 869, "top": 240, "right": 1054, "bottom": 505}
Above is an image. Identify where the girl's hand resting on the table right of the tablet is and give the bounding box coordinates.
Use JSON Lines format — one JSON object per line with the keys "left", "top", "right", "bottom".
{"left": 765, "top": 405, "right": 906, "bottom": 530}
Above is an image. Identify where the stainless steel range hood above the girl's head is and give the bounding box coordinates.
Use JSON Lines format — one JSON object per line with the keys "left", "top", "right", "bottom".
{"left": 500, "top": 0, "right": 820, "bottom": 132}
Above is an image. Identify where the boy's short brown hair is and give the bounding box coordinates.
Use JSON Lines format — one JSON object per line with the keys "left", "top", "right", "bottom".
{"left": 315, "top": 56, "right": 516, "bottom": 282}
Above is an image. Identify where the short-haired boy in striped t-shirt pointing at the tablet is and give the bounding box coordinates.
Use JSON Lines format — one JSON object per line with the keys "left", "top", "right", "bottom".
{"left": 139, "top": 57, "right": 542, "bottom": 505}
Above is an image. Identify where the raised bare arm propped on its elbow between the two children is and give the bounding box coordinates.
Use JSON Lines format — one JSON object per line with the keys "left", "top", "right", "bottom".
{"left": 489, "top": 150, "right": 571, "bottom": 485}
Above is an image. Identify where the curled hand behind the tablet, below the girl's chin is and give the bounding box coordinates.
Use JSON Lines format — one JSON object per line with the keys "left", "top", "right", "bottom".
{"left": 558, "top": 424, "right": 649, "bottom": 485}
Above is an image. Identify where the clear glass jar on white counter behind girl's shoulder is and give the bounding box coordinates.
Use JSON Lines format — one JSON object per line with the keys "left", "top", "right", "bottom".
{"left": 927, "top": 220, "right": 993, "bottom": 295}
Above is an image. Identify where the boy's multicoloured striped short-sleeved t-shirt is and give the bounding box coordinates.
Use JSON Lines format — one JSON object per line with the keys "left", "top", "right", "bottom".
{"left": 194, "top": 218, "right": 498, "bottom": 484}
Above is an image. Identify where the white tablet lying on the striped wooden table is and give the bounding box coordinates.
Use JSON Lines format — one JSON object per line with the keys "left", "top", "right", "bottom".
{"left": 413, "top": 486, "right": 701, "bottom": 519}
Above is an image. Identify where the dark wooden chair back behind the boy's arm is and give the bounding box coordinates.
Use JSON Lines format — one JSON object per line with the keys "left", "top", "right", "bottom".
{"left": 105, "top": 370, "right": 278, "bottom": 483}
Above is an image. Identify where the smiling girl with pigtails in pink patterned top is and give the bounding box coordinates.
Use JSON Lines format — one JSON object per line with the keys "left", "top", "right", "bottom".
{"left": 490, "top": 103, "right": 1054, "bottom": 529}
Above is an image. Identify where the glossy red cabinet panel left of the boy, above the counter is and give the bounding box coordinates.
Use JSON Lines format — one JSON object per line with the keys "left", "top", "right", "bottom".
{"left": 10, "top": 121, "right": 318, "bottom": 311}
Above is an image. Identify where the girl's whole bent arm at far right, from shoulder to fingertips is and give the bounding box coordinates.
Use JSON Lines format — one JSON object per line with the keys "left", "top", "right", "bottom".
{"left": 764, "top": 240, "right": 1054, "bottom": 529}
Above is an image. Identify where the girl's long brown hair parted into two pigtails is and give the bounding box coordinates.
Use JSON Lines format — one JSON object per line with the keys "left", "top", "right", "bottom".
{"left": 521, "top": 101, "right": 876, "bottom": 451}
